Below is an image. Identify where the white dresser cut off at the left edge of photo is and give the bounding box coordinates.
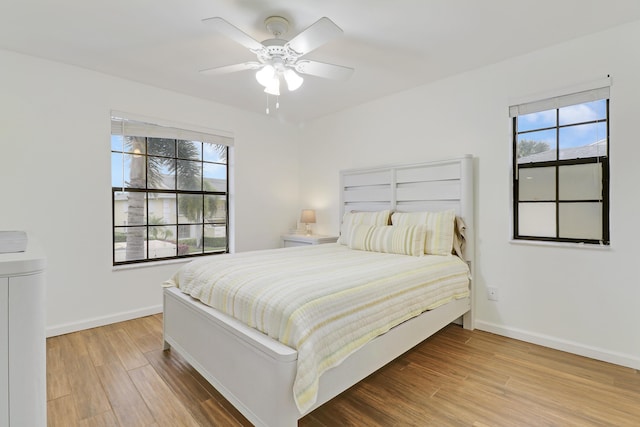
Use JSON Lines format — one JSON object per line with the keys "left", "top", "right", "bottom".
{"left": 0, "top": 237, "right": 47, "bottom": 427}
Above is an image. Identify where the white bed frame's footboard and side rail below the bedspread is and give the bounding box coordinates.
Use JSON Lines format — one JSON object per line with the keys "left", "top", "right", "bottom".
{"left": 164, "top": 288, "right": 471, "bottom": 427}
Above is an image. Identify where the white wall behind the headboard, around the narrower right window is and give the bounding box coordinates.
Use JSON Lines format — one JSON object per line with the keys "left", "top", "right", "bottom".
{"left": 300, "top": 23, "right": 640, "bottom": 368}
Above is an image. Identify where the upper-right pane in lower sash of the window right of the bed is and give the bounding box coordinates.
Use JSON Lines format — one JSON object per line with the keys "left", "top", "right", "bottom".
{"left": 558, "top": 163, "right": 602, "bottom": 200}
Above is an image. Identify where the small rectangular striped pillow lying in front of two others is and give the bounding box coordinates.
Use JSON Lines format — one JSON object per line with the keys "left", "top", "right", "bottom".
{"left": 349, "top": 224, "right": 427, "bottom": 256}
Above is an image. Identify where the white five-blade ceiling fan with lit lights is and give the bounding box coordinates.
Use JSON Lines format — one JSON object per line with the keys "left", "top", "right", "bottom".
{"left": 201, "top": 16, "right": 353, "bottom": 96}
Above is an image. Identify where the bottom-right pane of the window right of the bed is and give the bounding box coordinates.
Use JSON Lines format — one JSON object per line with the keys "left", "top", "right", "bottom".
{"left": 559, "top": 202, "right": 602, "bottom": 240}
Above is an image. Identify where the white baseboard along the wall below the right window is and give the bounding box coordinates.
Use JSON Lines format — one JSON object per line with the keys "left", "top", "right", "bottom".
{"left": 475, "top": 320, "right": 640, "bottom": 369}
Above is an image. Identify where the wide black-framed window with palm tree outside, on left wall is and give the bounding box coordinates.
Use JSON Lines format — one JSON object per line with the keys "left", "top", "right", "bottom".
{"left": 111, "top": 117, "right": 232, "bottom": 265}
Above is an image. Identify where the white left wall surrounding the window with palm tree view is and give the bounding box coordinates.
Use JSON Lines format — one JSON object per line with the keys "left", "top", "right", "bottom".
{"left": 0, "top": 50, "right": 299, "bottom": 334}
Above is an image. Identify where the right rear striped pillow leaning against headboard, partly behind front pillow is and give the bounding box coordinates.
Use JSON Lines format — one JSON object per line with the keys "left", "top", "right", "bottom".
{"left": 391, "top": 210, "right": 456, "bottom": 255}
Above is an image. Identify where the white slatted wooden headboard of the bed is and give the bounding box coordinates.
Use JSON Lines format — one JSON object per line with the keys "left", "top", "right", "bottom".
{"left": 340, "top": 154, "right": 475, "bottom": 261}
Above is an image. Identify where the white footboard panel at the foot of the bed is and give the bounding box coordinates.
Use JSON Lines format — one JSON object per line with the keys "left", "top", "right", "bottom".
{"left": 164, "top": 288, "right": 300, "bottom": 427}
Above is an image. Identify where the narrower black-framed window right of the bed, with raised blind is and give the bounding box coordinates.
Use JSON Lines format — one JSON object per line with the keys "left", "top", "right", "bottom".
{"left": 510, "top": 86, "right": 609, "bottom": 245}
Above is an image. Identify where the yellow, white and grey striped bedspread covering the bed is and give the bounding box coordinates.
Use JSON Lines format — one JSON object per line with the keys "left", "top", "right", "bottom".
{"left": 167, "top": 244, "right": 469, "bottom": 413}
